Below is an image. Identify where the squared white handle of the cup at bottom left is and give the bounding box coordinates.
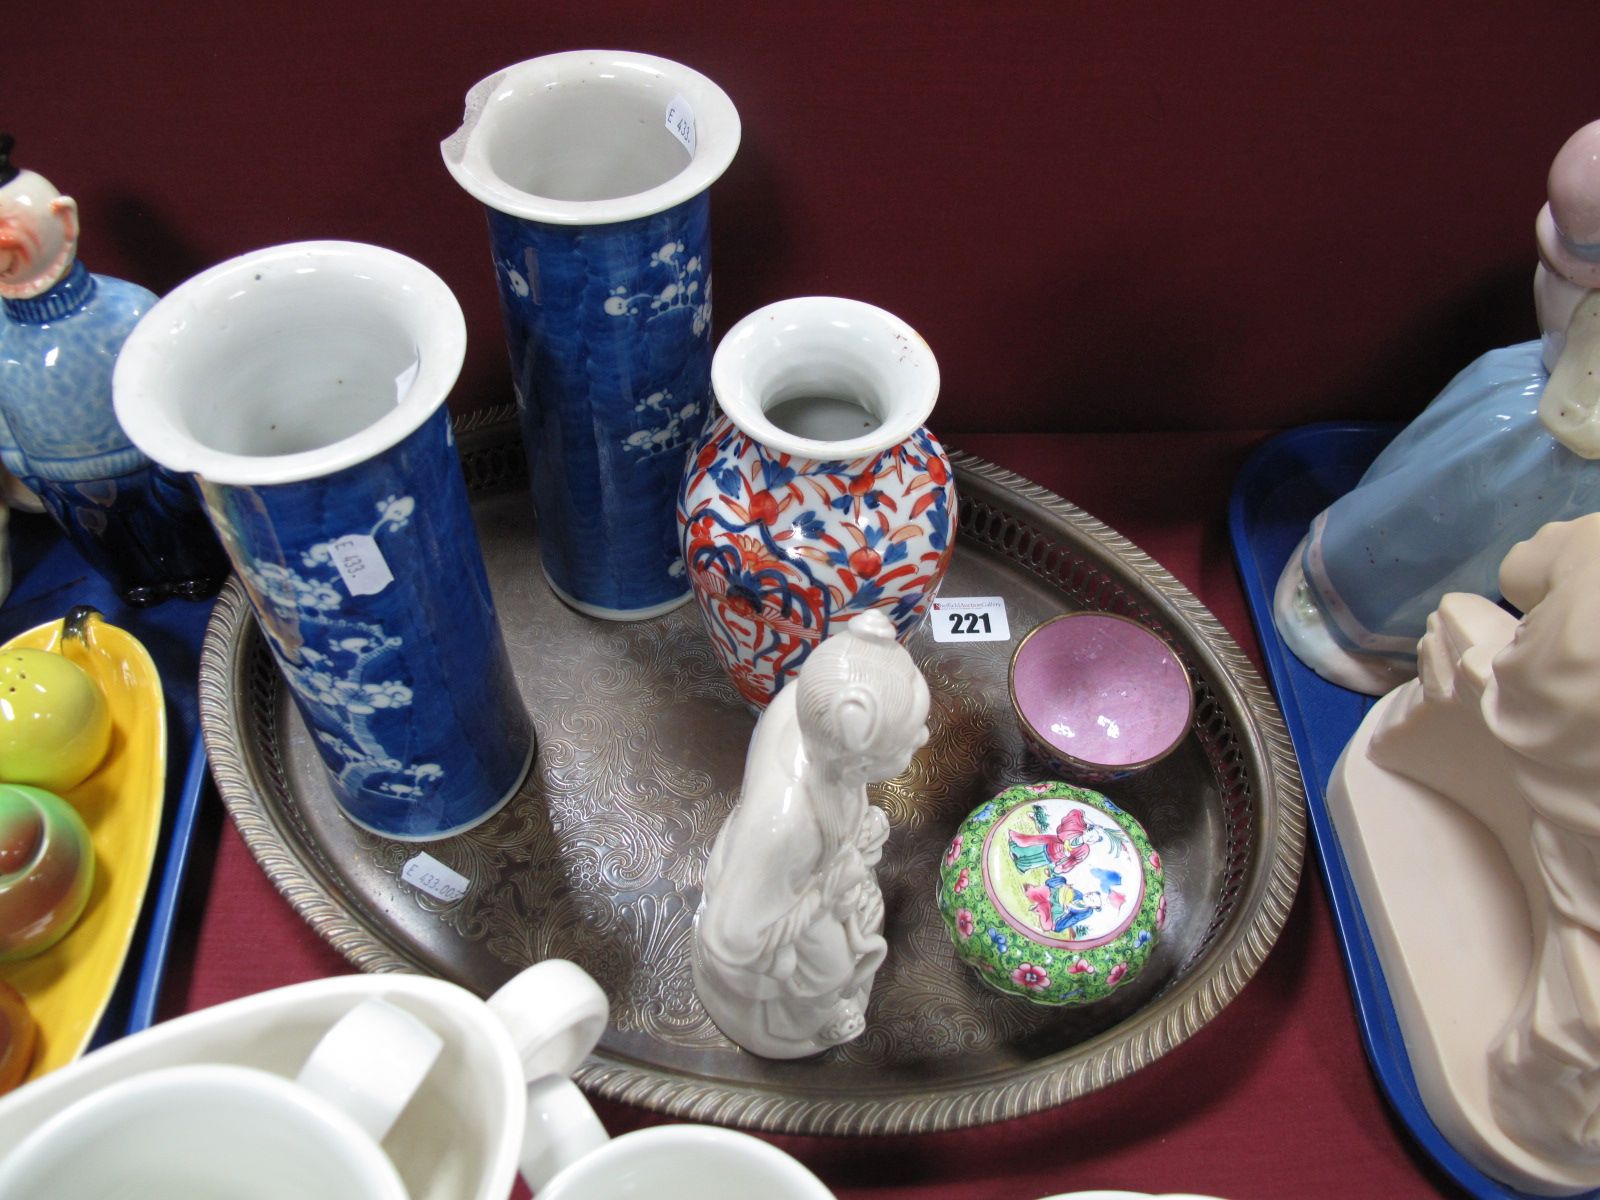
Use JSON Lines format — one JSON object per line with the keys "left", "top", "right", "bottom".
{"left": 296, "top": 1000, "right": 445, "bottom": 1142}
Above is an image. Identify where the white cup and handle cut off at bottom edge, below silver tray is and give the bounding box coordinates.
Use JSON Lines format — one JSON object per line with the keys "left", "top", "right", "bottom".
{"left": 522, "top": 1075, "right": 834, "bottom": 1200}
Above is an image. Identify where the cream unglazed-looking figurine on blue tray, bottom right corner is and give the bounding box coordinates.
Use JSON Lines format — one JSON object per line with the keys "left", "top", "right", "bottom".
{"left": 1328, "top": 514, "right": 1600, "bottom": 1195}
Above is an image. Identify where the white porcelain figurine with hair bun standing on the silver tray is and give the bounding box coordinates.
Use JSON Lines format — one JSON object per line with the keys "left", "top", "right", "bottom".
{"left": 694, "top": 611, "right": 928, "bottom": 1058}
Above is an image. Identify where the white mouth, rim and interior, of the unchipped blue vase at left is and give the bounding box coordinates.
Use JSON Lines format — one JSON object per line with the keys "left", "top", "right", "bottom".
{"left": 114, "top": 242, "right": 466, "bottom": 485}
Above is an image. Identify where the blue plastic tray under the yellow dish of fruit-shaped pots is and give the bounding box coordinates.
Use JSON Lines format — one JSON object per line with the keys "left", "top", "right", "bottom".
{"left": 0, "top": 512, "right": 211, "bottom": 1050}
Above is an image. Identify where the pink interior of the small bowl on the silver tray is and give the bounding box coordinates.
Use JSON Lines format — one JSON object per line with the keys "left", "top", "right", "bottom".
{"left": 1011, "top": 613, "right": 1190, "bottom": 766}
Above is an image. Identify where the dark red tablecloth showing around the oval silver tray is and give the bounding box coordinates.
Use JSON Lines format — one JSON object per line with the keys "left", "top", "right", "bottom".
{"left": 166, "top": 432, "right": 1450, "bottom": 1200}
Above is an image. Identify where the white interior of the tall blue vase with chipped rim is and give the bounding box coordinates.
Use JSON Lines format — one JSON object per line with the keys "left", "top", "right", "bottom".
{"left": 485, "top": 75, "right": 690, "bottom": 203}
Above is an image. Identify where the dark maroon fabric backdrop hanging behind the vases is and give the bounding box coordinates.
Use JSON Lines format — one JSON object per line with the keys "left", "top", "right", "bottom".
{"left": 12, "top": 0, "right": 1600, "bottom": 435}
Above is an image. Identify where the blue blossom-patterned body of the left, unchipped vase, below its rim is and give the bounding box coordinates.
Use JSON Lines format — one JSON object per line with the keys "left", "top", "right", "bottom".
{"left": 200, "top": 408, "right": 533, "bottom": 840}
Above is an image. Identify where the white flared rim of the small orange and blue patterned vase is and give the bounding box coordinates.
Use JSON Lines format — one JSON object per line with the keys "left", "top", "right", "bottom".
{"left": 710, "top": 296, "right": 939, "bottom": 462}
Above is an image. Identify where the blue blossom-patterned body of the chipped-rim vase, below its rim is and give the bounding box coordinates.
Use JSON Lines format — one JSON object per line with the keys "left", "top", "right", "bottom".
{"left": 488, "top": 192, "right": 710, "bottom": 619}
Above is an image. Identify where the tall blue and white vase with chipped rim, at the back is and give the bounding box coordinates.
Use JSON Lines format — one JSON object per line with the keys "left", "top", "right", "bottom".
{"left": 443, "top": 51, "right": 739, "bottom": 621}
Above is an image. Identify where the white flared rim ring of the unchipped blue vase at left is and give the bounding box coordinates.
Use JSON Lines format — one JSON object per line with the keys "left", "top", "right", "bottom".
{"left": 112, "top": 240, "right": 467, "bottom": 486}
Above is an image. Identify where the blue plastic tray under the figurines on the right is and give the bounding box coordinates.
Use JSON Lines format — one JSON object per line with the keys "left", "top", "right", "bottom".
{"left": 1227, "top": 424, "right": 1580, "bottom": 1198}
